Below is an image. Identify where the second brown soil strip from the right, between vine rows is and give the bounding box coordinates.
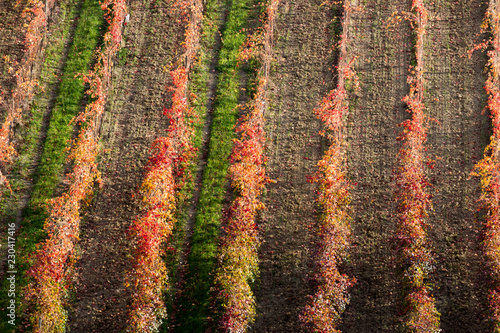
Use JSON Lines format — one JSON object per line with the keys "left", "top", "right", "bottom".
{"left": 342, "top": 0, "right": 412, "bottom": 332}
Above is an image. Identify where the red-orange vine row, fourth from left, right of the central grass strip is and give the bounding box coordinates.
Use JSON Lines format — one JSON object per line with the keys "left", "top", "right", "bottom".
{"left": 216, "top": 0, "right": 280, "bottom": 333}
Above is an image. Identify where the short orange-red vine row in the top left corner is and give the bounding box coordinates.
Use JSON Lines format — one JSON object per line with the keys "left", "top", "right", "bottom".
{"left": 0, "top": 0, "right": 56, "bottom": 189}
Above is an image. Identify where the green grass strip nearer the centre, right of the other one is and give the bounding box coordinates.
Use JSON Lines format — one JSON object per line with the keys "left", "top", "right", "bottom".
{"left": 175, "top": 0, "right": 252, "bottom": 333}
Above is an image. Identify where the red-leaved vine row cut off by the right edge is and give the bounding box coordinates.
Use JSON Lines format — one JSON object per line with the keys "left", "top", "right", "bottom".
{"left": 472, "top": 0, "right": 500, "bottom": 332}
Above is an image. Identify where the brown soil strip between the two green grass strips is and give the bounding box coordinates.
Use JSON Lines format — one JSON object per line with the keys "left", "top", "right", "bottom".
{"left": 65, "top": 1, "right": 183, "bottom": 332}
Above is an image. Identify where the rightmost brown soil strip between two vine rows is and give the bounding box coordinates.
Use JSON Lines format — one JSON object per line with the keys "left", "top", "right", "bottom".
{"left": 425, "top": 0, "right": 492, "bottom": 333}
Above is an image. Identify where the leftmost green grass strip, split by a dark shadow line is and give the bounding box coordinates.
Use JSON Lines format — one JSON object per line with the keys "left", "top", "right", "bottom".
{"left": 0, "top": 0, "right": 105, "bottom": 326}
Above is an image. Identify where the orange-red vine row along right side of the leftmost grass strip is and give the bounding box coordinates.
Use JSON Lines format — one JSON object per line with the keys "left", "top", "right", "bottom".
{"left": 25, "top": 0, "right": 126, "bottom": 333}
